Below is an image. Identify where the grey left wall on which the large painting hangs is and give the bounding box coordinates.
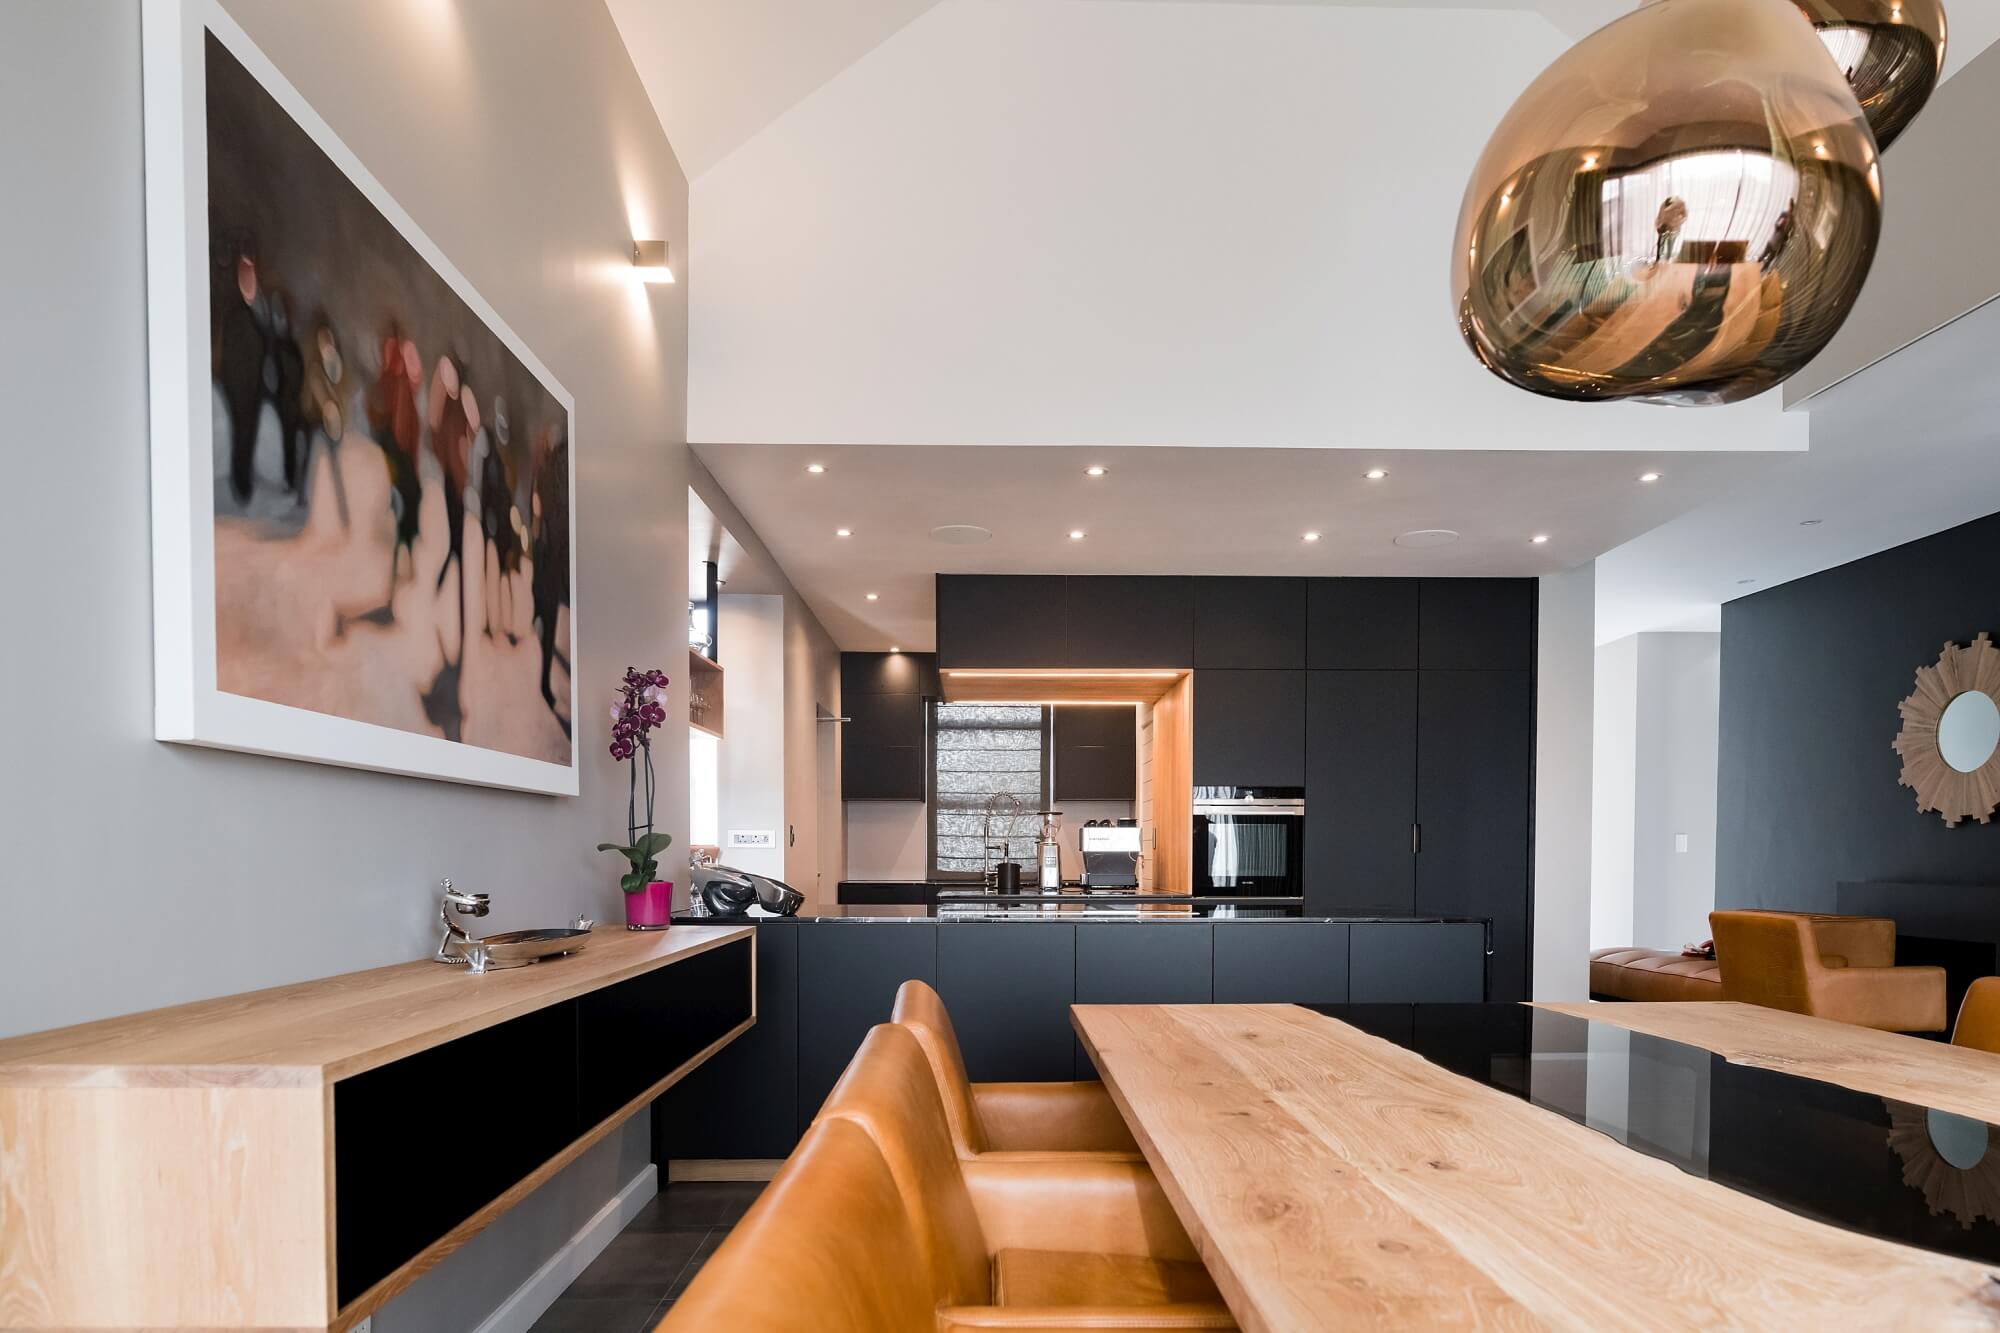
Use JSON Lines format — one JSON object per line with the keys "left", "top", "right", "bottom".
{"left": 0, "top": 0, "right": 688, "bottom": 1329}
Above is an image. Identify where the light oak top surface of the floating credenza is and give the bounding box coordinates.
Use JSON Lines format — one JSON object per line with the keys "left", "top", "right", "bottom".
{"left": 0, "top": 927, "right": 752, "bottom": 1087}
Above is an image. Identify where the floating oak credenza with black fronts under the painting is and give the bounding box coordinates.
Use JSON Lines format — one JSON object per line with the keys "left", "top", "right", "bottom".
{"left": 0, "top": 927, "right": 756, "bottom": 1329}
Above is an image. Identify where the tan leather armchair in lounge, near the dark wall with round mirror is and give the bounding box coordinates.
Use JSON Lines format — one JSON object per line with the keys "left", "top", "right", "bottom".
{"left": 1708, "top": 911, "right": 1944, "bottom": 1033}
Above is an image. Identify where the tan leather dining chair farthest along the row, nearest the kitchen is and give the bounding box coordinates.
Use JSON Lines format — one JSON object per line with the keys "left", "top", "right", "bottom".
{"left": 890, "top": 981, "right": 1140, "bottom": 1159}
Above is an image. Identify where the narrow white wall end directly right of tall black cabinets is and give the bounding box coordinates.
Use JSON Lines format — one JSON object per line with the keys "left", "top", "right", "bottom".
{"left": 1532, "top": 564, "right": 1598, "bottom": 1001}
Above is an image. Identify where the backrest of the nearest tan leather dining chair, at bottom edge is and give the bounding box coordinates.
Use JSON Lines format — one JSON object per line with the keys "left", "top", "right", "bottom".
{"left": 658, "top": 1121, "right": 938, "bottom": 1333}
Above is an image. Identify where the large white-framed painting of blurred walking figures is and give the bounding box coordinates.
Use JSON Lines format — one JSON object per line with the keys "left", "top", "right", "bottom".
{"left": 144, "top": 0, "right": 578, "bottom": 795}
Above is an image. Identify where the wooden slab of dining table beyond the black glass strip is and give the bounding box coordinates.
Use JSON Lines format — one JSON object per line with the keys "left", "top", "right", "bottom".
{"left": 1536, "top": 1001, "right": 2000, "bottom": 1125}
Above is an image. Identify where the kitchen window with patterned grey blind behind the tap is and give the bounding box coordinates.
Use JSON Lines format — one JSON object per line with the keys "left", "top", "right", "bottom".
{"left": 930, "top": 703, "right": 1048, "bottom": 879}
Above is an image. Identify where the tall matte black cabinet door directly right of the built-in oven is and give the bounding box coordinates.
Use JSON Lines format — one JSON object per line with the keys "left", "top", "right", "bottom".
{"left": 1306, "top": 671, "right": 1416, "bottom": 917}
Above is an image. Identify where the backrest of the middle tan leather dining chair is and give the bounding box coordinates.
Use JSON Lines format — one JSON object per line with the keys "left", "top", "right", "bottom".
{"left": 820, "top": 1023, "right": 992, "bottom": 1305}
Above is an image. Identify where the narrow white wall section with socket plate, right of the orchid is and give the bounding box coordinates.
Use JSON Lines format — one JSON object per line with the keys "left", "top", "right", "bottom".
{"left": 716, "top": 592, "right": 786, "bottom": 879}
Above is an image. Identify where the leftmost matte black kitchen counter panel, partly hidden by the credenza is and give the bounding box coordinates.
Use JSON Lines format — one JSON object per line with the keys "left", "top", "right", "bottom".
{"left": 652, "top": 923, "right": 802, "bottom": 1167}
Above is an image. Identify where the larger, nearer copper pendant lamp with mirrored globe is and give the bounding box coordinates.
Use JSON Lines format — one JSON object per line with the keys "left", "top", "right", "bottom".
{"left": 1452, "top": 0, "right": 1882, "bottom": 404}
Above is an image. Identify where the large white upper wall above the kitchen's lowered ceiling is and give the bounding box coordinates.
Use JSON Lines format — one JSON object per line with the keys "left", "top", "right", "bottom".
{"left": 690, "top": 0, "right": 1806, "bottom": 450}
